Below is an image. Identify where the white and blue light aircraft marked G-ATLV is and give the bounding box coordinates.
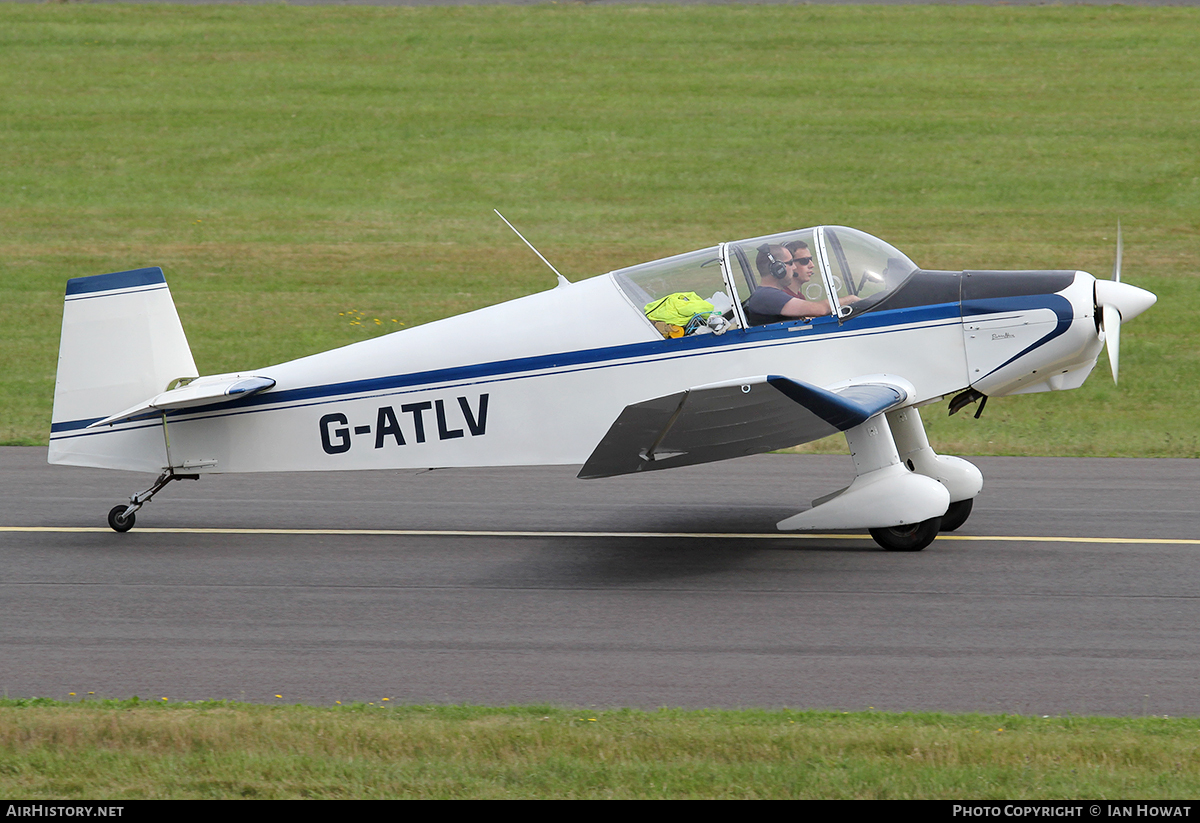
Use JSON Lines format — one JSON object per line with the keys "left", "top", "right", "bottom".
{"left": 49, "top": 221, "right": 1156, "bottom": 551}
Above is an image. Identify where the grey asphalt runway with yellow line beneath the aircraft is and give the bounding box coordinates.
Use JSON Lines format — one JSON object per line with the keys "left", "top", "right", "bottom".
{"left": 0, "top": 447, "right": 1200, "bottom": 716}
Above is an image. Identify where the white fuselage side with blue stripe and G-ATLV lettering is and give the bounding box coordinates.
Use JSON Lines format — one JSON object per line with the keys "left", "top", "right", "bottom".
{"left": 50, "top": 267, "right": 1099, "bottom": 471}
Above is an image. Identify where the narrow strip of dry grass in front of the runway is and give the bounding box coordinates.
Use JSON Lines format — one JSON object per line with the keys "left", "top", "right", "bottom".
{"left": 0, "top": 699, "right": 1200, "bottom": 800}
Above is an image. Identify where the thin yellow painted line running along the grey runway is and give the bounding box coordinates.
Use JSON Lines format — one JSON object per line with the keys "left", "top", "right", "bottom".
{"left": 0, "top": 525, "right": 1200, "bottom": 546}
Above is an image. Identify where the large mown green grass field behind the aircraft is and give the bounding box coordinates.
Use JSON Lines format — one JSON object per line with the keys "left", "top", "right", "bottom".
{"left": 0, "top": 4, "right": 1200, "bottom": 457}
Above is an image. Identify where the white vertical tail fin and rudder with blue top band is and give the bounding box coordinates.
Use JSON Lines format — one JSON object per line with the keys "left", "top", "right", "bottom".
{"left": 49, "top": 268, "right": 197, "bottom": 468}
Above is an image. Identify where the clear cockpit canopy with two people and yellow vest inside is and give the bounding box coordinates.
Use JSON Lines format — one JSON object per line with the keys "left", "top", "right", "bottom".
{"left": 611, "top": 226, "right": 918, "bottom": 337}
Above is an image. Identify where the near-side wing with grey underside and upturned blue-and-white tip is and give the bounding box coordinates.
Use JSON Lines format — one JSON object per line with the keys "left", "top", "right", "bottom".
{"left": 578, "top": 374, "right": 913, "bottom": 479}
